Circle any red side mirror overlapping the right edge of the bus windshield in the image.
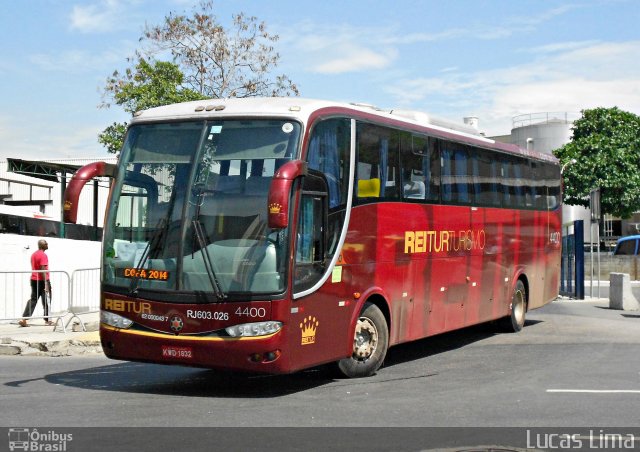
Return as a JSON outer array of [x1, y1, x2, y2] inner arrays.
[[267, 160, 307, 229]]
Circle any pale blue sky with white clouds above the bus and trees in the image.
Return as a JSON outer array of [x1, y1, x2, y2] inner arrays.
[[0, 0, 640, 159]]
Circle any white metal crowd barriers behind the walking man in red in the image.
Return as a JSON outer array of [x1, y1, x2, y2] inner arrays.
[[0, 268, 100, 331]]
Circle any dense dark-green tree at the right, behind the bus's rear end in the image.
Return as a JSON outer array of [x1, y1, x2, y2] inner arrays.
[[554, 107, 640, 218]]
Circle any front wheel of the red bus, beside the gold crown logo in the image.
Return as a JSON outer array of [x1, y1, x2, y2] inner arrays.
[[337, 302, 389, 378]]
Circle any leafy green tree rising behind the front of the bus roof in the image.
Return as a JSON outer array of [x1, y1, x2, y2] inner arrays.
[[98, 58, 204, 153]]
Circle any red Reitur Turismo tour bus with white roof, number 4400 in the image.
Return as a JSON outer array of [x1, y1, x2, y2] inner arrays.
[[65, 98, 561, 377]]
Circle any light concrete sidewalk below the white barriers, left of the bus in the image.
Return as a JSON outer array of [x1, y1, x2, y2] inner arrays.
[[0, 312, 102, 356]]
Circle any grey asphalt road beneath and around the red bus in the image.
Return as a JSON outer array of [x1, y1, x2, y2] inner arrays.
[[0, 302, 640, 450]]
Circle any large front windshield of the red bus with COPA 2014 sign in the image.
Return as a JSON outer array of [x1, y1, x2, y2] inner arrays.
[[103, 119, 300, 301]]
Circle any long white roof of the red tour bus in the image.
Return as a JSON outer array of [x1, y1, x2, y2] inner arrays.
[[131, 97, 557, 163]]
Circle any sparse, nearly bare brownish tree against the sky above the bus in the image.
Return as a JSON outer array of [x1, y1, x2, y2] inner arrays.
[[142, 1, 299, 99]]
